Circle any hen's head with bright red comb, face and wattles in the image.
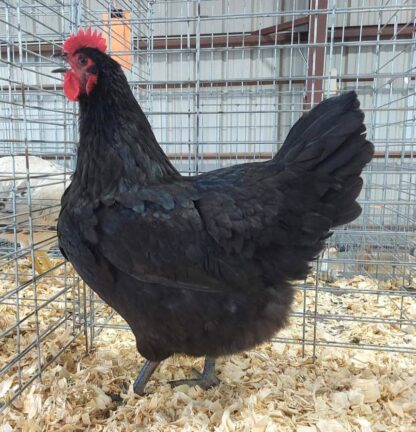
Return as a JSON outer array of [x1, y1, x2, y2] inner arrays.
[[52, 28, 107, 101]]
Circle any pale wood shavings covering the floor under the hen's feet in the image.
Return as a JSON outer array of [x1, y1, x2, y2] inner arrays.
[[0, 264, 416, 432]]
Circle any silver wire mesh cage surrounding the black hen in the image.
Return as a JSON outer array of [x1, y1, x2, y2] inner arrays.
[[0, 0, 416, 410]]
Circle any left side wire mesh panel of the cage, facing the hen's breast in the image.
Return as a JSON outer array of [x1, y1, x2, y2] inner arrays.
[[0, 0, 85, 410]]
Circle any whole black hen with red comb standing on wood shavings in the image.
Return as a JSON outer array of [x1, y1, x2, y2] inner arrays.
[[57, 30, 374, 393]]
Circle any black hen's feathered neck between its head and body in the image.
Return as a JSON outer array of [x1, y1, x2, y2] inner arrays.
[[73, 71, 179, 199]]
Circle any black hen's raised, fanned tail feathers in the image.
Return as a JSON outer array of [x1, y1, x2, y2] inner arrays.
[[275, 92, 374, 227]]
